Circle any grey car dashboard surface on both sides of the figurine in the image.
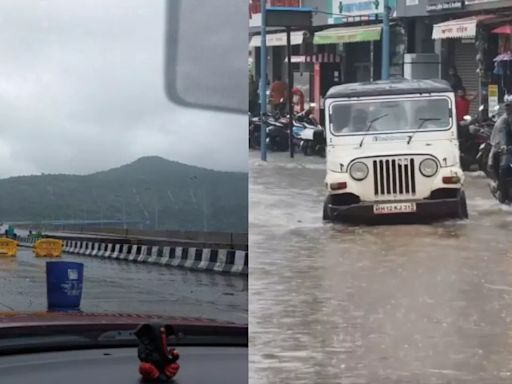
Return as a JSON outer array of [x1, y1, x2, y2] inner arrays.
[[0, 346, 248, 384]]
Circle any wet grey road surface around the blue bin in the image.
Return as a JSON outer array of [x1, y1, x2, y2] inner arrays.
[[0, 247, 248, 323]]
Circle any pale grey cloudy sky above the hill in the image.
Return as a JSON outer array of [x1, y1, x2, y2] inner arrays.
[[0, 0, 247, 177]]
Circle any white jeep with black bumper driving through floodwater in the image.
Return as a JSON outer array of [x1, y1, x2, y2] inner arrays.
[[323, 79, 468, 220]]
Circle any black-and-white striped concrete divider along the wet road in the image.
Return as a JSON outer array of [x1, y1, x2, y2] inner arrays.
[[19, 237, 249, 275]]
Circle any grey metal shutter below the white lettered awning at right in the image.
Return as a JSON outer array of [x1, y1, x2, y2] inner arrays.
[[455, 39, 480, 116]]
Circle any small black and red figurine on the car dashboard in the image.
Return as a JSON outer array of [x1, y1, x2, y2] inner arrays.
[[135, 323, 180, 383]]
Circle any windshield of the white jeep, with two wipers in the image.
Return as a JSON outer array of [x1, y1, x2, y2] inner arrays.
[[331, 98, 451, 135]]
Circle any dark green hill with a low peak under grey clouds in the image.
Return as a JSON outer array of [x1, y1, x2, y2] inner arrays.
[[0, 156, 248, 232]]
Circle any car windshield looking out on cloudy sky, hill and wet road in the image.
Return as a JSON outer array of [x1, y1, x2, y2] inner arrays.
[[0, 0, 248, 336]]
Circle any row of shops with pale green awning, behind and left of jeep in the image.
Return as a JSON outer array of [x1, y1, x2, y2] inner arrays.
[[249, 0, 405, 120]]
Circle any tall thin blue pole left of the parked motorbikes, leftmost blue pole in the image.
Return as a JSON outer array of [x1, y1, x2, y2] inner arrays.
[[260, 0, 267, 161]]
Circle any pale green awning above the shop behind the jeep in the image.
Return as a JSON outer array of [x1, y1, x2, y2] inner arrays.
[[313, 24, 382, 45]]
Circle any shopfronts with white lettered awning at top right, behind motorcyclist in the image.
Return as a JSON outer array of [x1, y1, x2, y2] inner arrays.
[[397, 0, 512, 113]]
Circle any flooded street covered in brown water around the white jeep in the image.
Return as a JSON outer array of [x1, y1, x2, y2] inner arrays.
[[249, 152, 512, 384]]
